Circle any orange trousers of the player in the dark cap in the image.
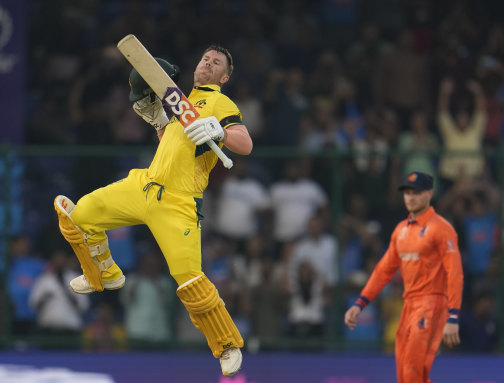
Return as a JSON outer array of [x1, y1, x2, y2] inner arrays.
[[403, 295, 444, 383]]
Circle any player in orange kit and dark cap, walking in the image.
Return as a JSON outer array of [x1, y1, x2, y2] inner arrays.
[[345, 172, 463, 383]]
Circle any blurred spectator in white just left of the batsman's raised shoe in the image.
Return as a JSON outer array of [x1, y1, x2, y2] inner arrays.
[[29, 250, 90, 336]]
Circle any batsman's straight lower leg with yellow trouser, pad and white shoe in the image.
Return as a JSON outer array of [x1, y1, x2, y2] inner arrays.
[[146, 192, 243, 375]]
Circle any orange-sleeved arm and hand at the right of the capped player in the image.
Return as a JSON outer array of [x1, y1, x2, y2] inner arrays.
[[438, 225, 464, 347]]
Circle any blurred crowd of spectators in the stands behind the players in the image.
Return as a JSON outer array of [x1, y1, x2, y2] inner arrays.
[[2, 0, 504, 352]]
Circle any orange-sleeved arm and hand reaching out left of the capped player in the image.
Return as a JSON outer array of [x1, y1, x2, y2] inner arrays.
[[345, 229, 401, 330]]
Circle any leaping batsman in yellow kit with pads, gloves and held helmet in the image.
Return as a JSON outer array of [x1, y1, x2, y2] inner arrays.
[[55, 45, 252, 376]]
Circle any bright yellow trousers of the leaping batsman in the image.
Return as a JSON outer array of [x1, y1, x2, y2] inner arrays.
[[72, 169, 202, 285]]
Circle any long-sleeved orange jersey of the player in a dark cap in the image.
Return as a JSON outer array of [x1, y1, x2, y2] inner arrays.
[[361, 207, 463, 311]]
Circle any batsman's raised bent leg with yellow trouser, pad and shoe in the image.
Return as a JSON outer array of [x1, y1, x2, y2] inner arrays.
[[55, 171, 145, 294]]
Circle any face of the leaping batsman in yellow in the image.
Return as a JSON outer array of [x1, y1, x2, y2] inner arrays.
[[194, 51, 229, 85]]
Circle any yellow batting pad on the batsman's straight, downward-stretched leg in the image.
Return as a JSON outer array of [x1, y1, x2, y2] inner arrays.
[[177, 275, 243, 358]]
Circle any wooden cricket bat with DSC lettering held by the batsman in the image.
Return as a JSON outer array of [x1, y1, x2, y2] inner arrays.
[[117, 34, 233, 169]]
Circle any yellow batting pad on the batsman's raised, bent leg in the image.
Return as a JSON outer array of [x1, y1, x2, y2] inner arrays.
[[54, 195, 104, 291]]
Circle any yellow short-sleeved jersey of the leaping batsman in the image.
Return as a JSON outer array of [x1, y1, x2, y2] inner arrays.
[[148, 85, 242, 197]]
